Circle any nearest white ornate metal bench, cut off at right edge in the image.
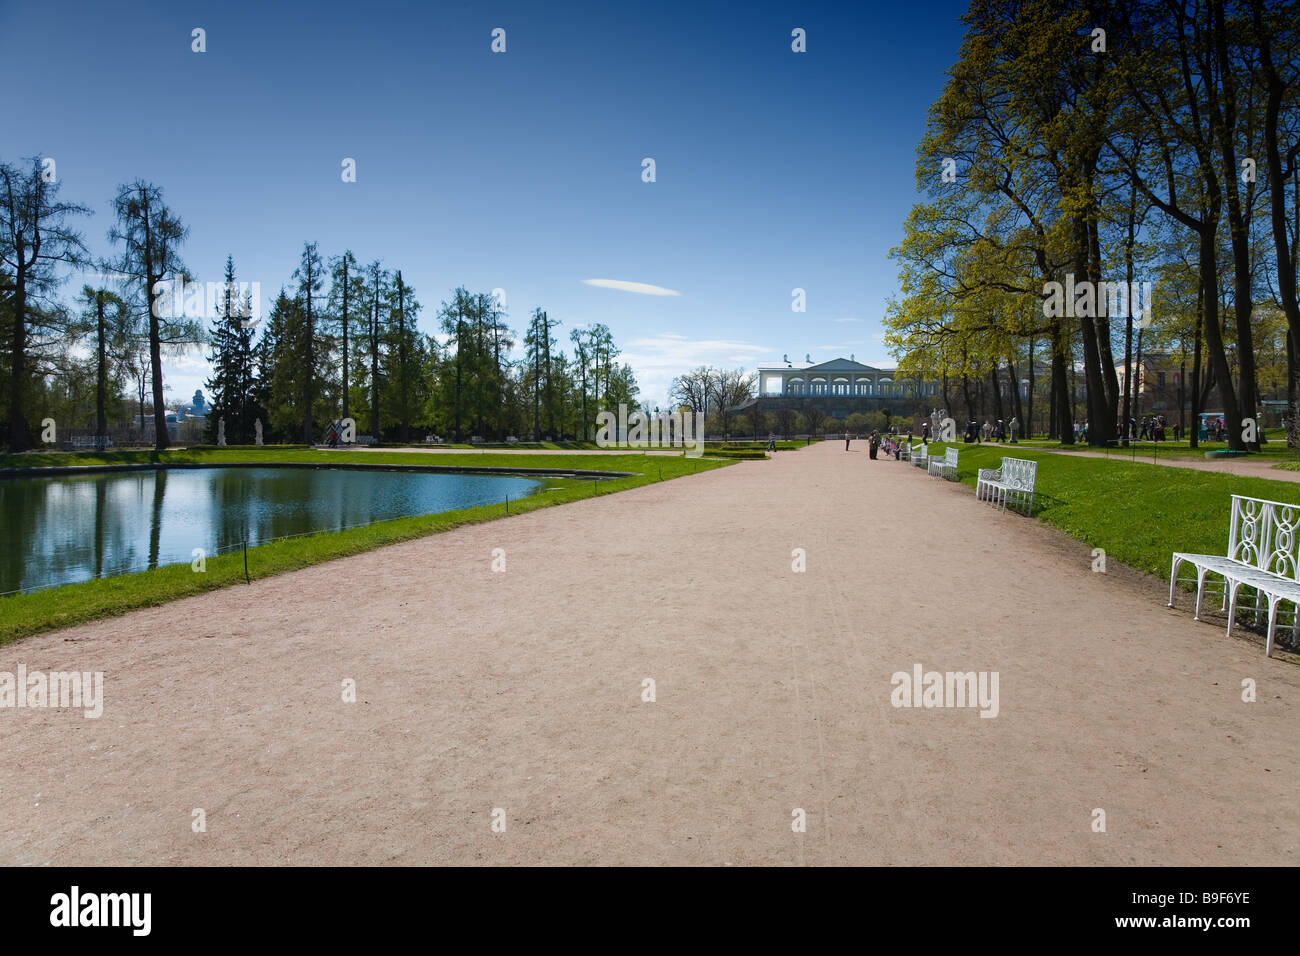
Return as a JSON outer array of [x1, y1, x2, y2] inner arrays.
[[1169, 494, 1300, 657]]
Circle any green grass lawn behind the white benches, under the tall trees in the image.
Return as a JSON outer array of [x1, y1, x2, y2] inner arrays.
[[930, 442, 1300, 580]]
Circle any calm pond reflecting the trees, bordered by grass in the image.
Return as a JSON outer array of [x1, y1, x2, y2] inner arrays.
[[0, 467, 545, 594]]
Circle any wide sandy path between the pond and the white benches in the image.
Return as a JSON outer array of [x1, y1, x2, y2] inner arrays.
[[0, 442, 1300, 865]]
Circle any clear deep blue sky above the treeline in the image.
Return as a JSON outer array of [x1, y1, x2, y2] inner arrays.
[[0, 0, 965, 403]]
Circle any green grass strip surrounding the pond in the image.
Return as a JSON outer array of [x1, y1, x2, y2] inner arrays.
[[0, 449, 731, 645]]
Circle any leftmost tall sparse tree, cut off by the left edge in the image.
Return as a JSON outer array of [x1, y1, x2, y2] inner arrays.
[[0, 156, 90, 451]]
